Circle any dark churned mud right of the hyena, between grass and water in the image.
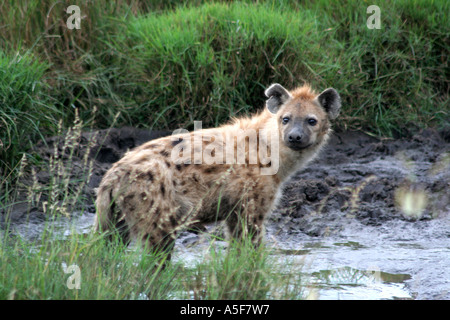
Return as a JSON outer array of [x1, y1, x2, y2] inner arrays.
[[272, 130, 450, 236]]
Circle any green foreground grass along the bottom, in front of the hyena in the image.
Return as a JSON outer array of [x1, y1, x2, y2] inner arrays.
[[0, 221, 303, 300]]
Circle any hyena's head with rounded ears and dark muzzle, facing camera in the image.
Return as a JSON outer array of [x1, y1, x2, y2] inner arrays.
[[265, 83, 341, 151]]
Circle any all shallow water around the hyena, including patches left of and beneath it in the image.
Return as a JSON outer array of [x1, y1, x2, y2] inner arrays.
[[7, 214, 450, 300]]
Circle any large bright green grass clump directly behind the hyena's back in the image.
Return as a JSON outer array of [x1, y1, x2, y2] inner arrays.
[[117, 3, 315, 128]]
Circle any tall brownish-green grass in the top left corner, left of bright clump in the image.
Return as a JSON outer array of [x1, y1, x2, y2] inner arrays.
[[0, 0, 198, 127]]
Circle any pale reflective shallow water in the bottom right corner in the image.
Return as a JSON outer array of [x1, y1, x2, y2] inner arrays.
[[268, 218, 450, 299]]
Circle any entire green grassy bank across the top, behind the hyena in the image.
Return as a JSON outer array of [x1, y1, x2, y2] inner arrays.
[[0, 0, 450, 180]]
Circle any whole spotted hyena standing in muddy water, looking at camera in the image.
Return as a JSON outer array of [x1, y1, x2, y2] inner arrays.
[[95, 84, 341, 260]]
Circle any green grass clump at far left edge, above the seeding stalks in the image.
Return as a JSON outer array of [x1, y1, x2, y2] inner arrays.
[[0, 51, 61, 179]]
